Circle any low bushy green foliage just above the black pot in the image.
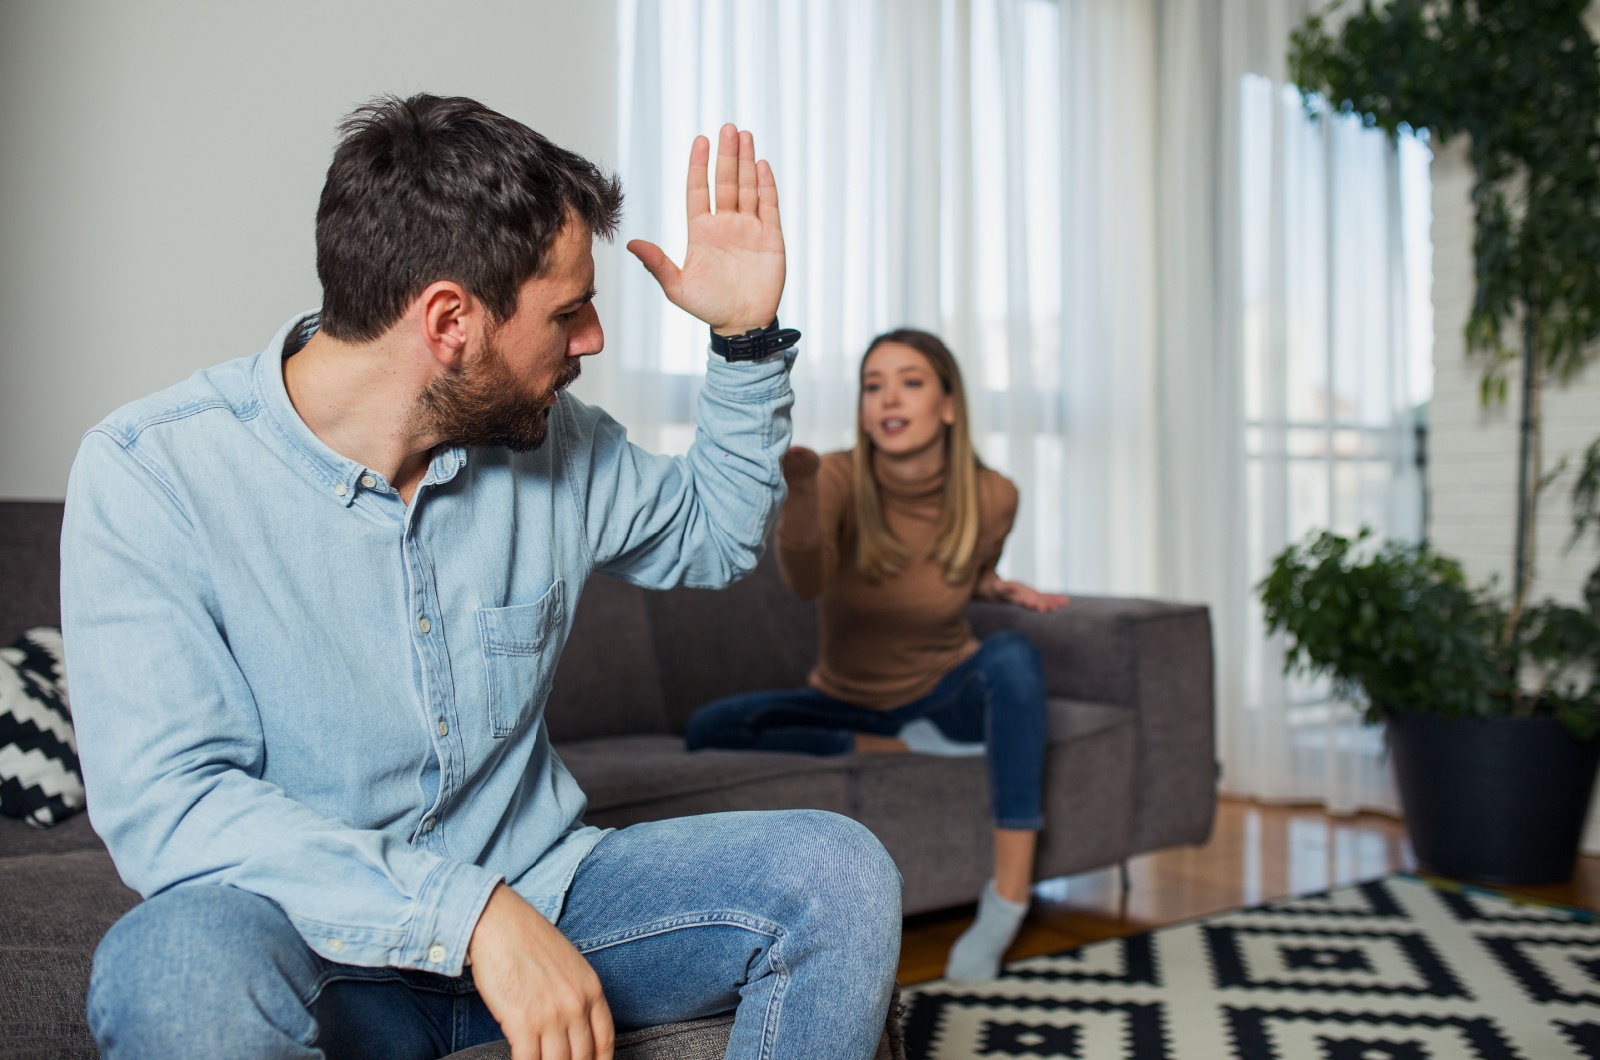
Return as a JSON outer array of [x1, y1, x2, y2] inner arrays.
[[1256, 530, 1600, 738]]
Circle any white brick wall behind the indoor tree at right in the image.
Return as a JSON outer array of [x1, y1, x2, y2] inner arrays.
[[1429, 143, 1600, 853]]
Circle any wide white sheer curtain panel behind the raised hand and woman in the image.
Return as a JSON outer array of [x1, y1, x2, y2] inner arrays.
[[606, 0, 1155, 592]]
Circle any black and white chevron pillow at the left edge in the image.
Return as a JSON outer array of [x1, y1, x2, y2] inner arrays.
[[0, 628, 83, 828]]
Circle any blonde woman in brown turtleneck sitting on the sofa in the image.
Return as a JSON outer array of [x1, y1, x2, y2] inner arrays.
[[686, 328, 1067, 982]]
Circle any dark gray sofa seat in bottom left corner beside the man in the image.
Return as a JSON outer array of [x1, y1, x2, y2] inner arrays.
[[0, 849, 139, 1057]]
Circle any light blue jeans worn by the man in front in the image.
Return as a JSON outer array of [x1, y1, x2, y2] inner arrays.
[[88, 810, 901, 1060]]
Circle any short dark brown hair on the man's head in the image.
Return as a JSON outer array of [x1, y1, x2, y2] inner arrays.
[[317, 94, 622, 341]]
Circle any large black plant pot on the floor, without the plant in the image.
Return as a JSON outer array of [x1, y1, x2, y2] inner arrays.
[[1387, 711, 1600, 884]]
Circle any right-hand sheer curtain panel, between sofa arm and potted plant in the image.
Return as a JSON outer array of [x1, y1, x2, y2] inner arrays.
[[1158, 0, 1432, 812]]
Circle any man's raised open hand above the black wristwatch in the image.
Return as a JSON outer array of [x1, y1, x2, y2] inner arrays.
[[627, 125, 784, 335]]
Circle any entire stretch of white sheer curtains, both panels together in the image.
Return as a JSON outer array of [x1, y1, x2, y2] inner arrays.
[[614, 0, 1429, 810]]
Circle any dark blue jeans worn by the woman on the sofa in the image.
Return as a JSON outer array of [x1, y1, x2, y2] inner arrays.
[[685, 631, 1048, 831]]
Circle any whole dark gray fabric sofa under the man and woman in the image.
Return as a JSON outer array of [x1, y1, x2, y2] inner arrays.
[[0, 501, 1214, 1060]]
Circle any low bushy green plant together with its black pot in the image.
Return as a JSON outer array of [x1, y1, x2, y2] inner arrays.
[[1258, 532, 1600, 884]]
